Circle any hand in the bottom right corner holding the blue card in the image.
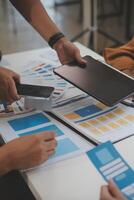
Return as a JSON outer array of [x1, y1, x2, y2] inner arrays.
[[100, 180, 125, 200]]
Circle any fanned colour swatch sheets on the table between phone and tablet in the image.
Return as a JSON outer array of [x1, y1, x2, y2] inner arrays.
[[21, 60, 68, 100]]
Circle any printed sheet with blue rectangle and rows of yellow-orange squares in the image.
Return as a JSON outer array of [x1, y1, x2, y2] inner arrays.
[[53, 94, 134, 143]]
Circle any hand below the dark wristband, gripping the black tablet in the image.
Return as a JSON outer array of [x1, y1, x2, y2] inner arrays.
[[53, 38, 86, 64]]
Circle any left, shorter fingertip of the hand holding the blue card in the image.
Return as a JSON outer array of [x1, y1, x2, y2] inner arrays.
[[100, 185, 112, 200]]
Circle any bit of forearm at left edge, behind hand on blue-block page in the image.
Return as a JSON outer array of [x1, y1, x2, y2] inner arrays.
[[0, 145, 12, 176]]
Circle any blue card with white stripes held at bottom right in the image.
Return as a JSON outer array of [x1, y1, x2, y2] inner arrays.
[[87, 142, 134, 199]]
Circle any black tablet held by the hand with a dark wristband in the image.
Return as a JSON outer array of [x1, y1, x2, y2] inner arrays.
[[54, 56, 134, 106]]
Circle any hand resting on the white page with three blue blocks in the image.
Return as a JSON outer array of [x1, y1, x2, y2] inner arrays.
[[2, 131, 56, 171]]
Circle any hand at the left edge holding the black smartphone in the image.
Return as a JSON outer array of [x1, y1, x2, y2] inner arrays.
[[0, 67, 20, 103]]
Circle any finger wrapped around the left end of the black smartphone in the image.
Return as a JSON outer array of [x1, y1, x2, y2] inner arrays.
[[9, 78, 20, 101]]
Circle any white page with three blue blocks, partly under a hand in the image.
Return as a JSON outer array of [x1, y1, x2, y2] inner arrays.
[[0, 111, 92, 166]]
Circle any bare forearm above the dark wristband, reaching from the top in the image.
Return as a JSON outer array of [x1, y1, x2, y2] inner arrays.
[[10, 0, 59, 41]]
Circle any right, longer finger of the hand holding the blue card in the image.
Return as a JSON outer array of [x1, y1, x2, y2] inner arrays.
[[108, 179, 123, 199]]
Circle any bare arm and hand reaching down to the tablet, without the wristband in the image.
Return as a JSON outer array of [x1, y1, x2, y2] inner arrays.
[[10, 0, 85, 64]]
